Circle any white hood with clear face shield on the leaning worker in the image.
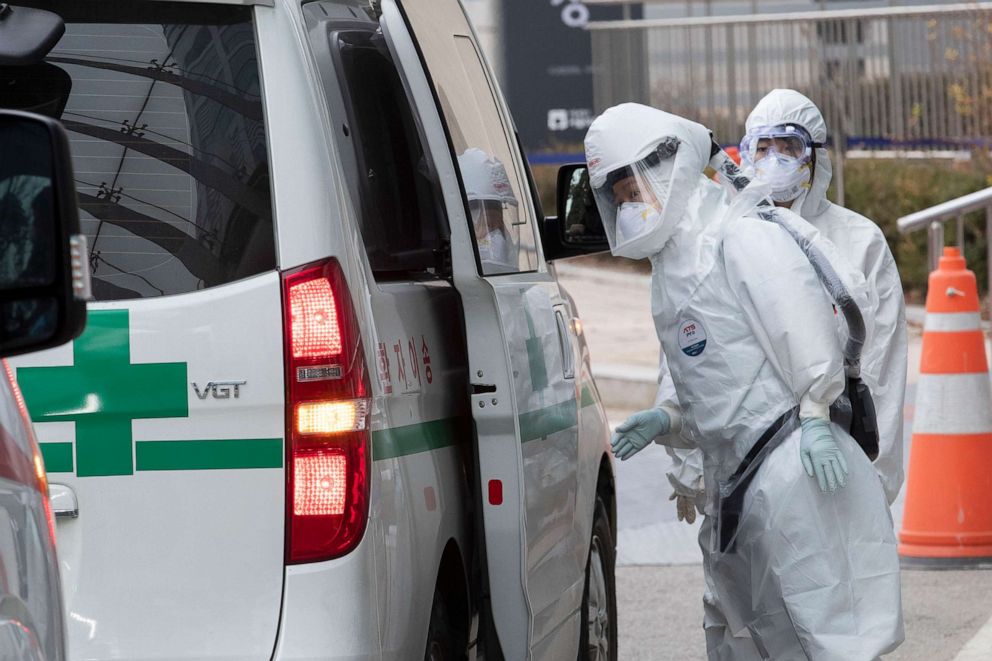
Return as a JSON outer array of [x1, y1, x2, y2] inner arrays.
[[585, 103, 712, 259]]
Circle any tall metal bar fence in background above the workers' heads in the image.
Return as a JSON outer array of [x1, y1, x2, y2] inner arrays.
[[588, 2, 992, 151]]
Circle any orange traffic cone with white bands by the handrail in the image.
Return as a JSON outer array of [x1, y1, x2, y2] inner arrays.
[[899, 248, 992, 568]]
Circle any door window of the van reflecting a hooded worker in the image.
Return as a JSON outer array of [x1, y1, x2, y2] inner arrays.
[[396, 2, 539, 275]]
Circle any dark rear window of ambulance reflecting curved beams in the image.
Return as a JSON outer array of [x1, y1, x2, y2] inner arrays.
[[0, 0, 276, 300]]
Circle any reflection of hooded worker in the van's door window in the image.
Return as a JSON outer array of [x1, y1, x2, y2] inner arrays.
[[458, 147, 519, 275]]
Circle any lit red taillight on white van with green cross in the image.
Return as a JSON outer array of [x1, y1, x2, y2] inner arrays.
[[283, 259, 371, 563]]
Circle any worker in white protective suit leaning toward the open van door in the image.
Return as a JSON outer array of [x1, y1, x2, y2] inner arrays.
[[586, 104, 903, 660]]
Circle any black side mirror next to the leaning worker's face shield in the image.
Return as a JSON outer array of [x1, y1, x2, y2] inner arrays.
[[542, 163, 610, 260]]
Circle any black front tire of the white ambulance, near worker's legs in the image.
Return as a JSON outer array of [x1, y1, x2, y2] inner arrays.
[[579, 497, 617, 661]]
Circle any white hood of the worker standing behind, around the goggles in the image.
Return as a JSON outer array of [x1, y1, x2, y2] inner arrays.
[[744, 89, 833, 218]]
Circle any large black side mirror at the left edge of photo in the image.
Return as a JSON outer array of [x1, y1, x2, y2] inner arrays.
[[0, 110, 90, 357]]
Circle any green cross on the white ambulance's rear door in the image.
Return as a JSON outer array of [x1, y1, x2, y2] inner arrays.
[[17, 310, 189, 477]]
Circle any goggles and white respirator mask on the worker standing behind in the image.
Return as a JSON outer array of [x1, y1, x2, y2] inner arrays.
[[740, 124, 823, 202]]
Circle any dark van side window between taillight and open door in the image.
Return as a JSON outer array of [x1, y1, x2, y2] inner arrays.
[[306, 3, 448, 280]]
